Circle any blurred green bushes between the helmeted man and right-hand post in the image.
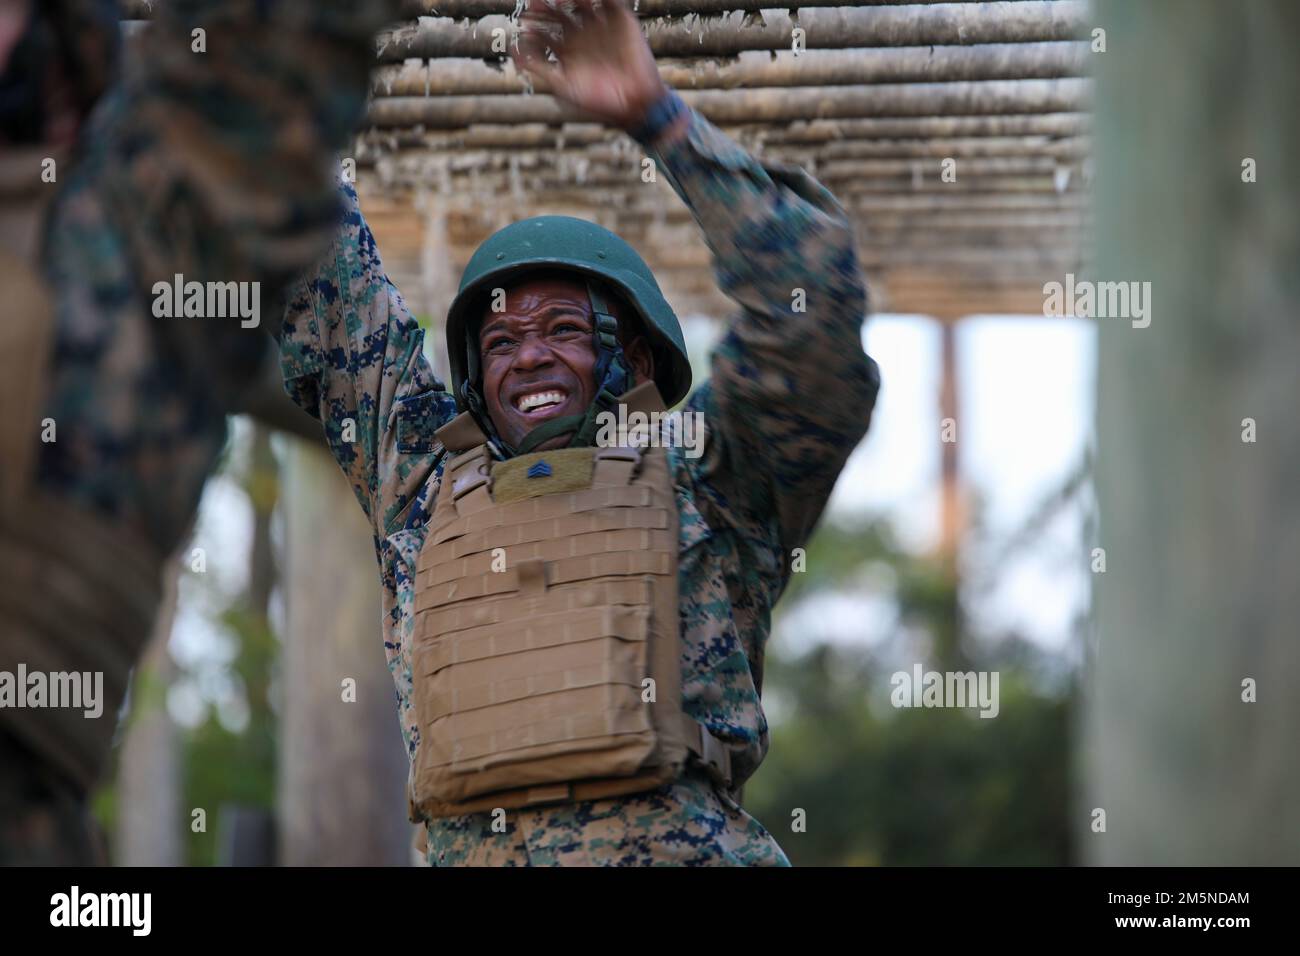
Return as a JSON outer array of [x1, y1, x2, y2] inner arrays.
[[744, 523, 1075, 866]]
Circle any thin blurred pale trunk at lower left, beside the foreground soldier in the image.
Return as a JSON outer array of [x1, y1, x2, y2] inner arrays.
[[113, 561, 185, 866]]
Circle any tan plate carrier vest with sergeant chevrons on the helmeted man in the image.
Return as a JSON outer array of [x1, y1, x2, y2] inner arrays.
[[411, 382, 731, 819]]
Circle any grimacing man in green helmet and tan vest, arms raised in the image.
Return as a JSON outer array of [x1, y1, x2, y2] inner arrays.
[[281, 0, 879, 866]]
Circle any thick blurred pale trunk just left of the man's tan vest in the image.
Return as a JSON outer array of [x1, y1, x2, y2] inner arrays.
[[277, 441, 411, 866]]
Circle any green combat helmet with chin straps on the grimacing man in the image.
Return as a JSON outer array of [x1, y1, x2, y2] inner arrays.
[[447, 216, 690, 457]]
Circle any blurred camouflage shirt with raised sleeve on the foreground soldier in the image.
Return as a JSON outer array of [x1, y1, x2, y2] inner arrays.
[[38, 0, 397, 553]]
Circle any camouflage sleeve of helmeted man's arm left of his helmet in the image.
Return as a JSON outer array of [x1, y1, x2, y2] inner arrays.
[[280, 185, 456, 538]]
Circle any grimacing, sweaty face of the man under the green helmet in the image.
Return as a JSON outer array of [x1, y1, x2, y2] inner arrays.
[[478, 273, 654, 450]]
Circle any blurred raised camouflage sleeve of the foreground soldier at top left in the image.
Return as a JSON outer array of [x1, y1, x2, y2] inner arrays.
[[99, 0, 398, 345]]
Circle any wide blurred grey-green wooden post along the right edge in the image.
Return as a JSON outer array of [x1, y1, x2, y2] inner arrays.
[[1079, 0, 1300, 865]]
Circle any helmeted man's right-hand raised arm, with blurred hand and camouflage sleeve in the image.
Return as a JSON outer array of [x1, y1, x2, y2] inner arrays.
[[515, 0, 879, 574]]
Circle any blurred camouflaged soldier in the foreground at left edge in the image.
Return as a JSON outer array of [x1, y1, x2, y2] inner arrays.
[[0, 0, 395, 864]]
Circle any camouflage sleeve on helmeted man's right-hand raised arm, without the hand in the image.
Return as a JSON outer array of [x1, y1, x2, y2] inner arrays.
[[650, 112, 880, 580]]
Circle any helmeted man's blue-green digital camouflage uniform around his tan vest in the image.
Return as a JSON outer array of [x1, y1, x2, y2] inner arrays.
[[282, 104, 879, 865]]
